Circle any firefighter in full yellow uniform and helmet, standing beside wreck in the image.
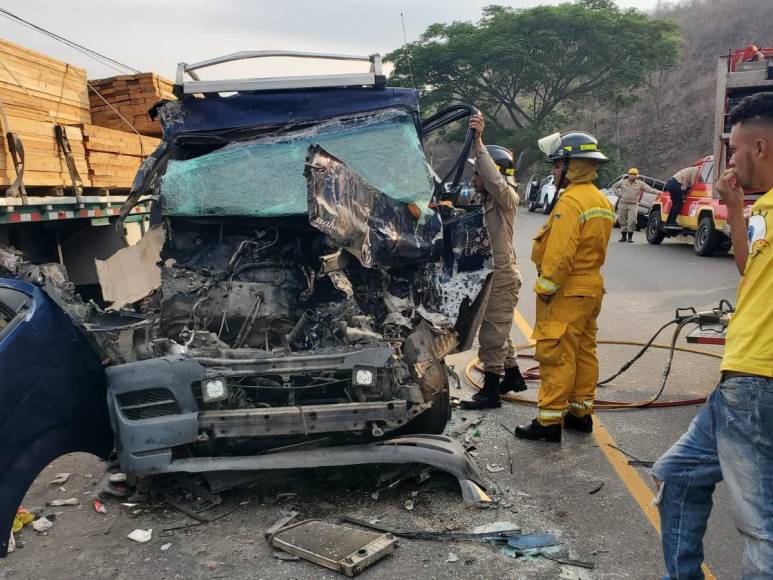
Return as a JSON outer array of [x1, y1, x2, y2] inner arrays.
[[515, 131, 615, 442]]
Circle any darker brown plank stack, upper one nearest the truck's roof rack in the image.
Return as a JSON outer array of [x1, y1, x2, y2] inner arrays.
[[90, 73, 175, 137]]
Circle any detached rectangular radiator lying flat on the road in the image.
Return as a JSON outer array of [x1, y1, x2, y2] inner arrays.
[[269, 520, 395, 577]]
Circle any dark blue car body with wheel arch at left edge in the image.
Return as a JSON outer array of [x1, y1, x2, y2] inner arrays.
[[0, 279, 113, 556]]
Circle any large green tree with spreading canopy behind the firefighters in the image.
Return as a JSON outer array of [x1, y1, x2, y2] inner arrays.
[[386, 0, 681, 165]]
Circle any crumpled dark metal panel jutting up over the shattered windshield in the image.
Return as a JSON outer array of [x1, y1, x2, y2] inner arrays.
[[306, 145, 443, 268]]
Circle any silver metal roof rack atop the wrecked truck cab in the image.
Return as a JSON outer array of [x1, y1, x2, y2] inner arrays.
[[175, 50, 386, 96]]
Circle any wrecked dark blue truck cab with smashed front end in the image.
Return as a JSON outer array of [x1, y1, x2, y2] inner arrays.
[[106, 55, 491, 478]]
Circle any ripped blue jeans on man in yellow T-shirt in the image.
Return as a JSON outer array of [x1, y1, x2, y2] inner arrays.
[[652, 377, 773, 580]]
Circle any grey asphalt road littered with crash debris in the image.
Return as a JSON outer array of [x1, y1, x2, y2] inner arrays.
[[6, 211, 741, 579]]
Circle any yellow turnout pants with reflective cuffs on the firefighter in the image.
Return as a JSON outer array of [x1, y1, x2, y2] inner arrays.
[[532, 274, 604, 425]]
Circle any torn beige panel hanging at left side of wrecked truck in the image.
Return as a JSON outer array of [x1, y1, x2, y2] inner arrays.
[[94, 225, 166, 310]]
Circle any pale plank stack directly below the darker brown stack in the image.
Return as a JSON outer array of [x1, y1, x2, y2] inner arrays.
[[78, 124, 160, 188]]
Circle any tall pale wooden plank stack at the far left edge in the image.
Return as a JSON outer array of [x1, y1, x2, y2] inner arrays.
[[0, 39, 91, 187]]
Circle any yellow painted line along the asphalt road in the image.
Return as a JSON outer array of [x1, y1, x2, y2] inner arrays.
[[513, 310, 716, 580]]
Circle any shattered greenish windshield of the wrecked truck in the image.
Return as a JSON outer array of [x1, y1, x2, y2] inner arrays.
[[161, 109, 433, 217]]
